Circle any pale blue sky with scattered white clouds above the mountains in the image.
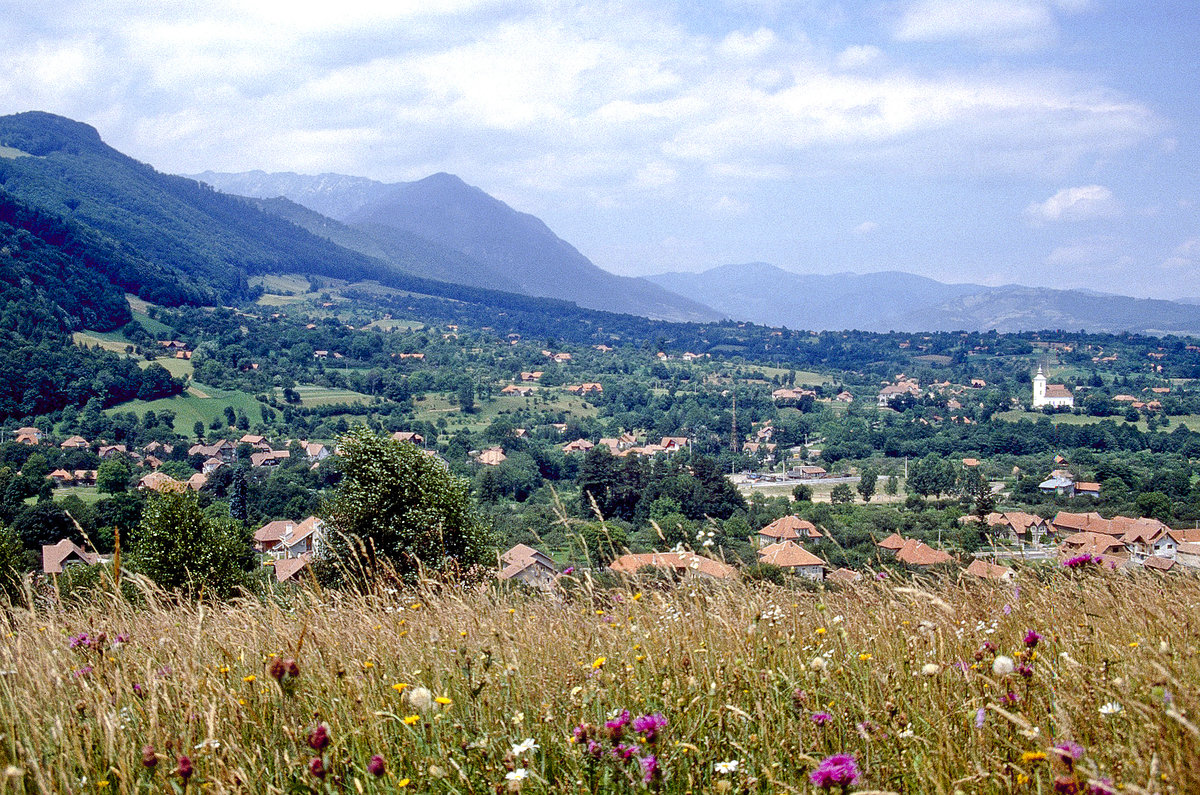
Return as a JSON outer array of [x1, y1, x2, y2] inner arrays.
[[0, 0, 1200, 298]]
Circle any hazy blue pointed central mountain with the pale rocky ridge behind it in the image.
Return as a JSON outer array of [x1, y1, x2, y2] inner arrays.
[[192, 172, 721, 322]]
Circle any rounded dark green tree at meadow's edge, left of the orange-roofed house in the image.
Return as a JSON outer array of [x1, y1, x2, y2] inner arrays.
[[130, 492, 254, 597]]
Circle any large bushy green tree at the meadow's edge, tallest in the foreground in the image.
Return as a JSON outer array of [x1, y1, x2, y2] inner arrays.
[[325, 425, 493, 586]]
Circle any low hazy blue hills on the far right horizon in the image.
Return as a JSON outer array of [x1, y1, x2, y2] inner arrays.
[[648, 263, 1200, 334]]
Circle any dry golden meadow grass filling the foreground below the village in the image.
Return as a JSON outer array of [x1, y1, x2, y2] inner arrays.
[[0, 570, 1200, 794]]
